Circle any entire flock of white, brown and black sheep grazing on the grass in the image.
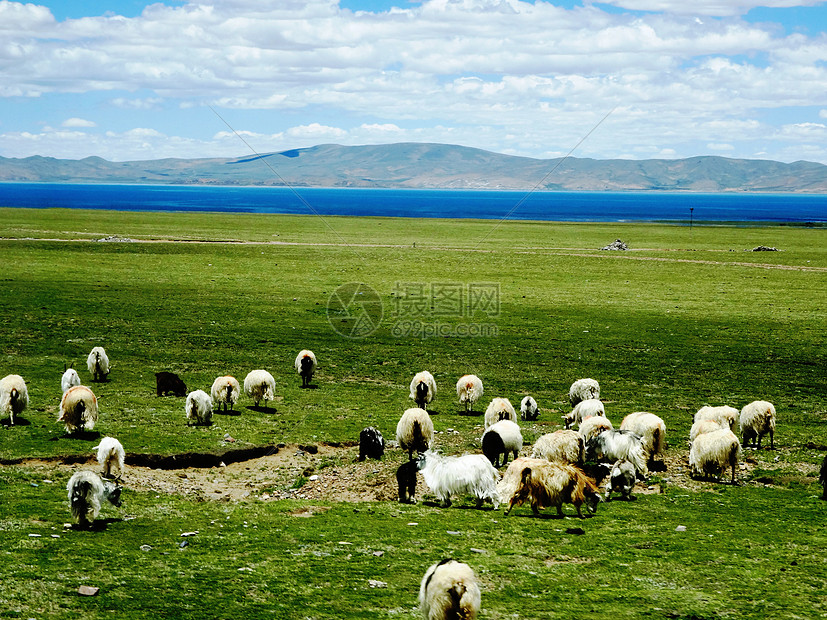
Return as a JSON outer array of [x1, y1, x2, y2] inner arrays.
[[0, 346, 827, 619]]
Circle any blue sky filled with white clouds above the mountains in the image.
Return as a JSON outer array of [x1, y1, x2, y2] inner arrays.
[[0, 0, 827, 164]]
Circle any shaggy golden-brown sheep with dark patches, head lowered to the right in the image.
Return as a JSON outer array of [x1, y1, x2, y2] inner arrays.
[[497, 459, 600, 519]]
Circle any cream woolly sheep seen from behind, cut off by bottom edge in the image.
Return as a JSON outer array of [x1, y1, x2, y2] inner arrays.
[[419, 558, 480, 620]]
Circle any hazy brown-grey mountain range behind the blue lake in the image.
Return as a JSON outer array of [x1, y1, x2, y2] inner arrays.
[[0, 143, 827, 193]]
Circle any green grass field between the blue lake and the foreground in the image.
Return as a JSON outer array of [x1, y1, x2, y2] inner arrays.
[[0, 209, 827, 620]]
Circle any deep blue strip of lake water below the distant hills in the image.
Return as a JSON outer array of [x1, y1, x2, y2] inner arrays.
[[0, 183, 827, 223]]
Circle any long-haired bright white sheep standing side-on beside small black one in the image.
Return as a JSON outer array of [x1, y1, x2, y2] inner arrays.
[[419, 450, 500, 510]]
